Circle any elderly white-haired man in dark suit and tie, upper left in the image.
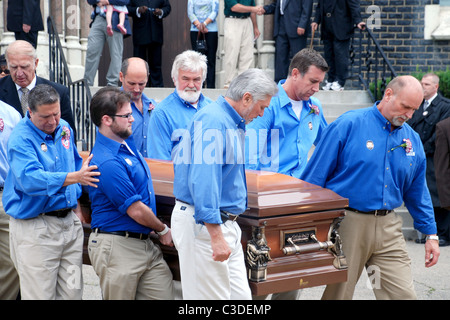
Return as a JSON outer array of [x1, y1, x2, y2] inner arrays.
[[0, 40, 76, 136]]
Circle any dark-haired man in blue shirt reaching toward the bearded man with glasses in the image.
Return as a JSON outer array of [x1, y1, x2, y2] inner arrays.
[[3, 85, 99, 300]]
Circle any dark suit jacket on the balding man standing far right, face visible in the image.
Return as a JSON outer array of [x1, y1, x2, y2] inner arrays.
[[408, 94, 450, 207]]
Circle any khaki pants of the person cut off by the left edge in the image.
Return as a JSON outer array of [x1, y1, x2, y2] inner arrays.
[[0, 191, 19, 300]]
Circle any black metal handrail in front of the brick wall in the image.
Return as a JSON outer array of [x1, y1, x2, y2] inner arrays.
[[350, 28, 397, 101]]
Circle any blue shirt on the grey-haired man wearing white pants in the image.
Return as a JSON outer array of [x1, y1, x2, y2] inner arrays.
[[173, 97, 247, 224]]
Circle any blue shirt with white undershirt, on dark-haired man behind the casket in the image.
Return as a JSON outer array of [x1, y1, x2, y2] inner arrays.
[[245, 80, 327, 178]]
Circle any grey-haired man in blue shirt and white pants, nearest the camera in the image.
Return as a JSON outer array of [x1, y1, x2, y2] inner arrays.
[[171, 69, 277, 299]]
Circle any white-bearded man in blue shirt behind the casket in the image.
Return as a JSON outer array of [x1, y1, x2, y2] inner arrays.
[[147, 50, 212, 160]]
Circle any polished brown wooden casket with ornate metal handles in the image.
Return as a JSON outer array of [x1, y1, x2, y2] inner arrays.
[[81, 152, 348, 296]]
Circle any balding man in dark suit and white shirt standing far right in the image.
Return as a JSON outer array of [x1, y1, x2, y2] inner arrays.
[[407, 73, 450, 247]]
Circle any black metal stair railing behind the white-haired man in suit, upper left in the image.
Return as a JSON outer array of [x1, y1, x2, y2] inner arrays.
[[47, 16, 96, 150]]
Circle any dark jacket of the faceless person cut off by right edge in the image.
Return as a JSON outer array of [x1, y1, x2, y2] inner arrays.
[[434, 118, 450, 209]]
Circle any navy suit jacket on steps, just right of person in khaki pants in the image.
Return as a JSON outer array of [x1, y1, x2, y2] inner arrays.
[[264, 0, 313, 38]]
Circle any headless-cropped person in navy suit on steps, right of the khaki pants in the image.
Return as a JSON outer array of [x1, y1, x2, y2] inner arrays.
[[264, 0, 313, 82]]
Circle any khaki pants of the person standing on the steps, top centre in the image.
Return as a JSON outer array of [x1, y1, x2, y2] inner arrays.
[[223, 18, 254, 87]]
